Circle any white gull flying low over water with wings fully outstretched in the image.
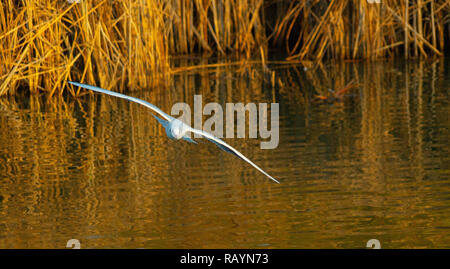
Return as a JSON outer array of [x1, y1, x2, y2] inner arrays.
[[68, 81, 280, 183]]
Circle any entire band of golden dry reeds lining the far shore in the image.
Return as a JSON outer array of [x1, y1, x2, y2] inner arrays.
[[0, 0, 450, 96]]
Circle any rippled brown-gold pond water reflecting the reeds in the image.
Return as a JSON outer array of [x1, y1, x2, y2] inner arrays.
[[0, 59, 450, 248]]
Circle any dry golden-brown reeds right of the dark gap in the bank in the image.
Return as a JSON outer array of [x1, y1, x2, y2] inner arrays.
[[274, 0, 450, 60]]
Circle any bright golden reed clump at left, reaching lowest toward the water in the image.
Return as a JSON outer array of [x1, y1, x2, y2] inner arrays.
[[0, 0, 171, 95]]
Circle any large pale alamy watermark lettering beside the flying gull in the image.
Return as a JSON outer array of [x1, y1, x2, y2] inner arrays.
[[170, 95, 280, 149]]
